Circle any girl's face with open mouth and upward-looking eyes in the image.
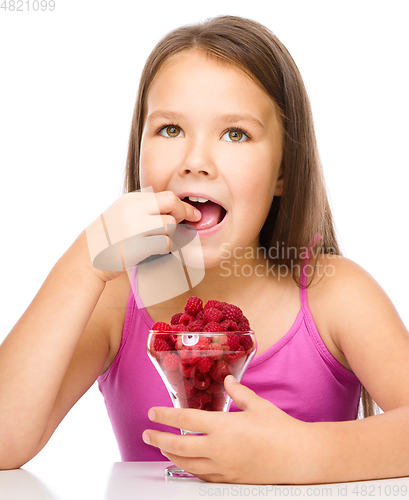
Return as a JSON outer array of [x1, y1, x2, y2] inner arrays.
[[140, 50, 283, 268]]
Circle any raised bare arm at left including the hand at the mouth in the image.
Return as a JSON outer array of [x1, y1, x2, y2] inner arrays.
[[0, 192, 200, 469]]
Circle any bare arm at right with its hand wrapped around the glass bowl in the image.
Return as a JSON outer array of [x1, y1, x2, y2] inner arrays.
[[144, 259, 409, 484]]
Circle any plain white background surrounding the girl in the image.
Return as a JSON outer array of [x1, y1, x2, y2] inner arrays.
[[0, 0, 409, 496]]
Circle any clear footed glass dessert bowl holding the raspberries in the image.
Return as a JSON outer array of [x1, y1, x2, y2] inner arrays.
[[147, 330, 257, 477]]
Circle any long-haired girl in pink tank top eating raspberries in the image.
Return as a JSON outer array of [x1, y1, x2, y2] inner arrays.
[[0, 16, 409, 484]]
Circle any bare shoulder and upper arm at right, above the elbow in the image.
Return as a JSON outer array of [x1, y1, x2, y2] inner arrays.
[[309, 255, 409, 411]]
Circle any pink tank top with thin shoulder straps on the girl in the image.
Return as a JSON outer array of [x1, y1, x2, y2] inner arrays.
[[98, 250, 361, 461]]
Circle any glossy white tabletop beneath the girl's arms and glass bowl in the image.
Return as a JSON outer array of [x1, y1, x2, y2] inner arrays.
[[0, 462, 409, 500]]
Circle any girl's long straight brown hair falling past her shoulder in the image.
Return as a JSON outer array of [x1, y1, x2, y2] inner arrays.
[[124, 16, 373, 416]]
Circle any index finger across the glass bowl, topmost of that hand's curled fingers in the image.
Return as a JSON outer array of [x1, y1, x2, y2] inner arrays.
[[148, 406, 217, 434]]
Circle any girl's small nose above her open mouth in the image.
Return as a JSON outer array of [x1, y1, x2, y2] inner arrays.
[[179, 140, 217, 178]]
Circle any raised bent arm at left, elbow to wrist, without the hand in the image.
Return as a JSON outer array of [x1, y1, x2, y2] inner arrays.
[[0, 233, 109, 469]]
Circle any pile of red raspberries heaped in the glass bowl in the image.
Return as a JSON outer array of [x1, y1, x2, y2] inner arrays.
[[148, 297, 255, 411]]
